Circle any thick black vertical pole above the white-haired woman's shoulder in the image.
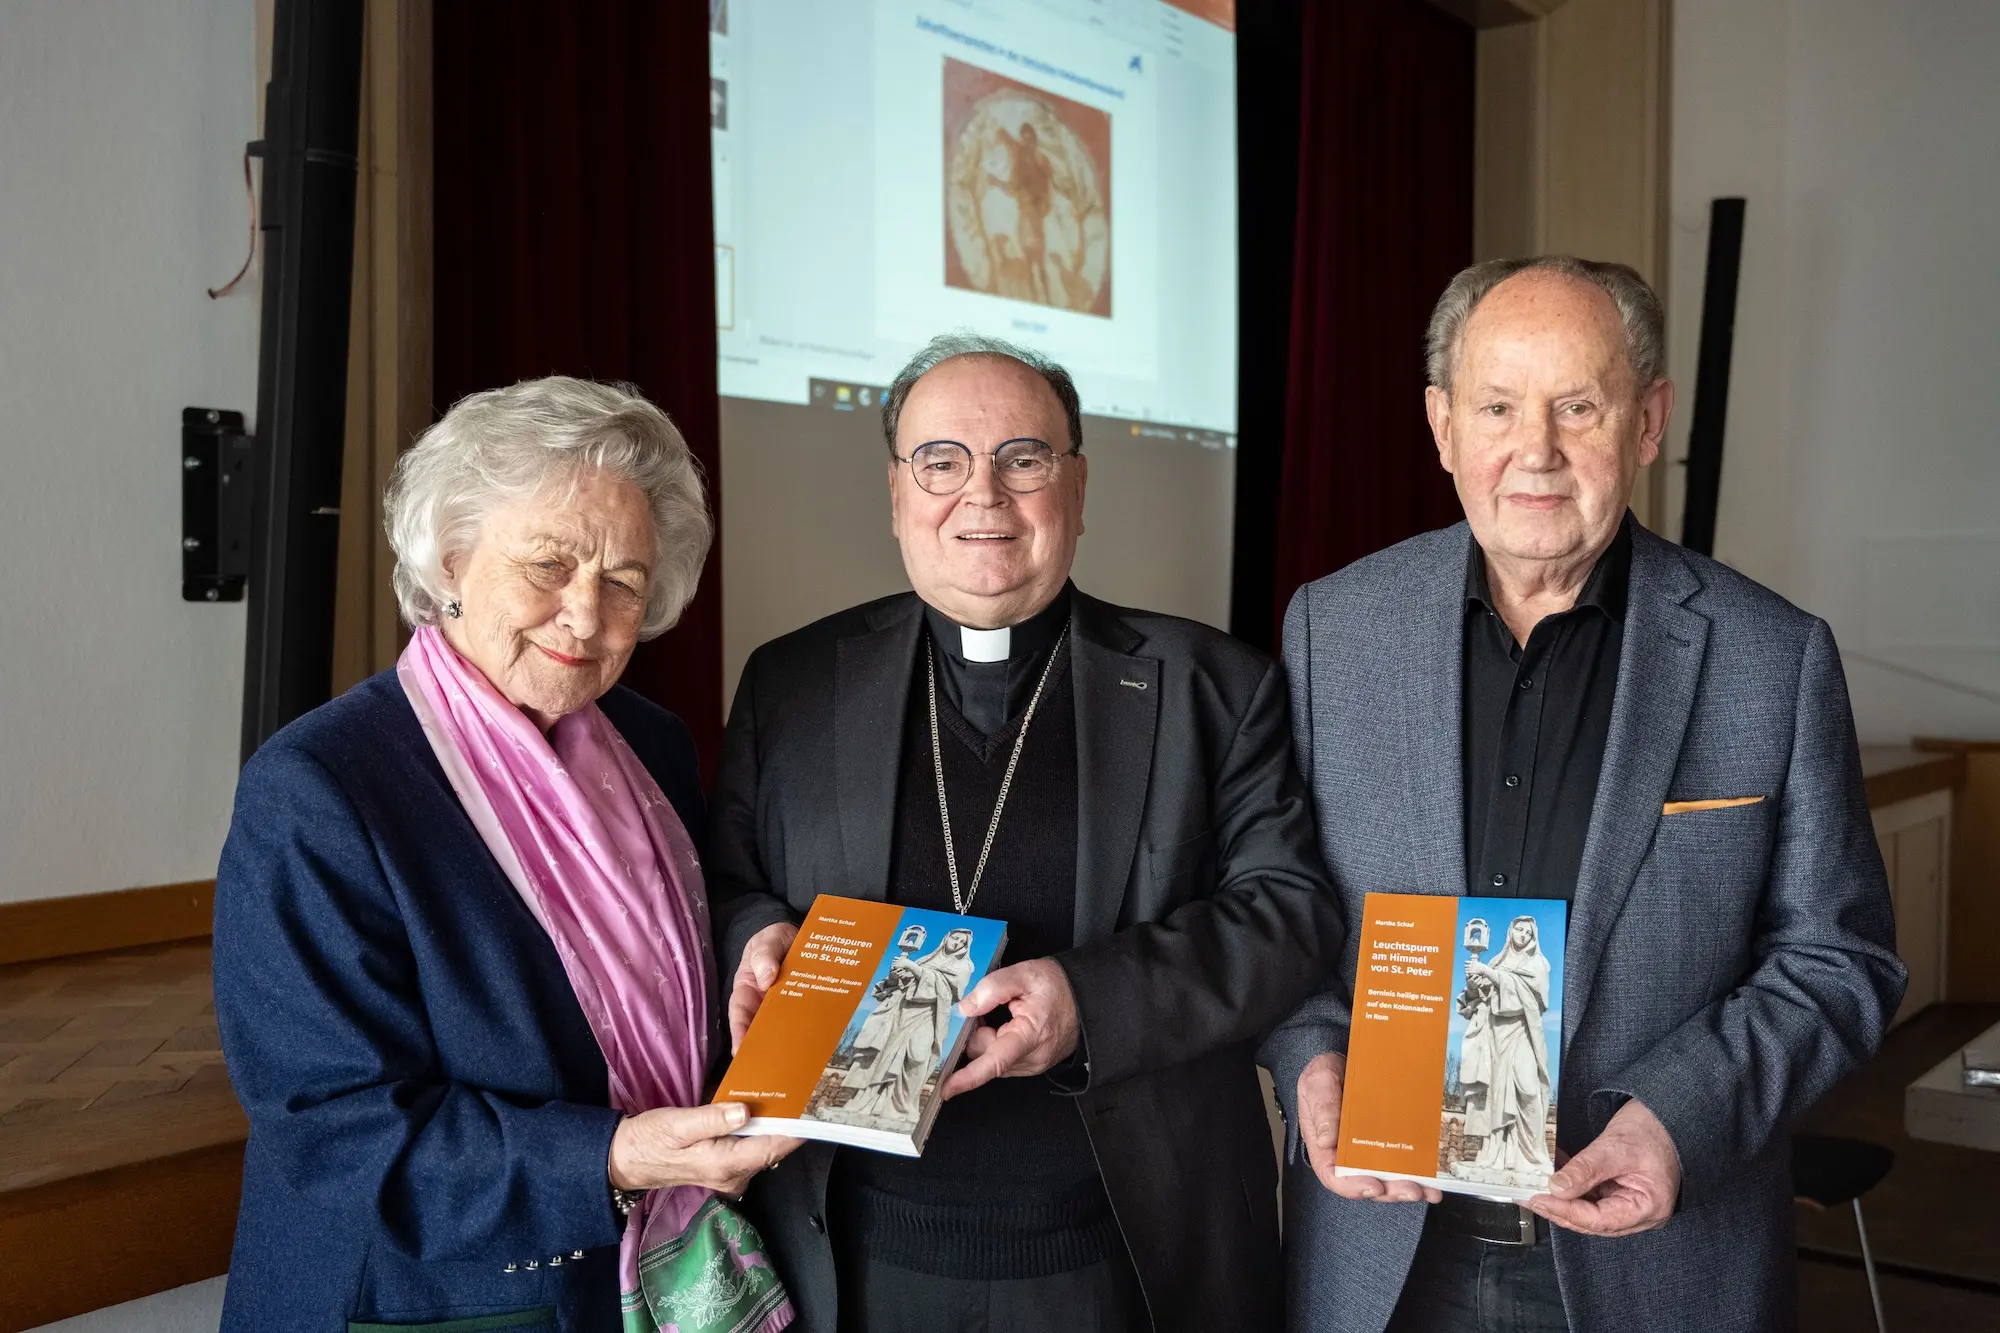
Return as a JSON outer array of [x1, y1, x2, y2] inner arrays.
[[242, 0, 362, 759]]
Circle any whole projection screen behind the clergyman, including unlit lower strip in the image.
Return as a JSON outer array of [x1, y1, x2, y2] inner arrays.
[[710, 0, 1236, 693]]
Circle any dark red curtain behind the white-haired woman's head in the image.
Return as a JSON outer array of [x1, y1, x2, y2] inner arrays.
[[434, 0, 722, 777]]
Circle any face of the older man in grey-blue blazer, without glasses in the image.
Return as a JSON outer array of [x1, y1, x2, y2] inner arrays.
[[1424, 270, 1674, 562]]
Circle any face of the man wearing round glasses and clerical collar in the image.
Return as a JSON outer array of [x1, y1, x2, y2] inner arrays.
[[888, 356, 1088, 628]]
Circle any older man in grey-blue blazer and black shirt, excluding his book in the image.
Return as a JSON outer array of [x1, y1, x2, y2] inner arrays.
[[1260, 256, 1904, 1333]]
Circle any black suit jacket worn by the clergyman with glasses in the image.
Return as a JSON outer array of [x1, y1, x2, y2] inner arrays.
[[704, 592, 1340, 1333]]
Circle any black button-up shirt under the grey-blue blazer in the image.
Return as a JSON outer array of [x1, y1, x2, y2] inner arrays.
[[1462, 514, 1632, 899]]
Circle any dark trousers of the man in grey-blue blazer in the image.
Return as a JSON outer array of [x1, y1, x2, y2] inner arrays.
[[1386, 1217, 1570, 1333]]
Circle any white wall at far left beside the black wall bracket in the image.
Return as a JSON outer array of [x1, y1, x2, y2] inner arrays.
[[0, 0, 258, 901]]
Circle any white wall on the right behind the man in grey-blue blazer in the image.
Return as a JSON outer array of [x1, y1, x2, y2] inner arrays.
[[1668, 0, 2000, 741]]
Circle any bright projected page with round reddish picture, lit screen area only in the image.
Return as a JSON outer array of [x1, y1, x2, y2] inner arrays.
[[710, 0, 1236, 442]]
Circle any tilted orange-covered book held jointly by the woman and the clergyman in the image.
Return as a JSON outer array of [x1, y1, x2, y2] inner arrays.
[[716, 893, 1006, 1157]]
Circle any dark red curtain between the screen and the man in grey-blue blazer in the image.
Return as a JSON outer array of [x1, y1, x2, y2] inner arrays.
[[1272, 0, 1474, 620]]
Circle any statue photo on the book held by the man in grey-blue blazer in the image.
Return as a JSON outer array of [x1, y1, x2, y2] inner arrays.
[[1438, 899, 1568, 1191]]
